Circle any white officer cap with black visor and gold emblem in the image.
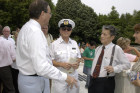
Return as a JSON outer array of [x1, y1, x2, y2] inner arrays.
[[58, 19, 75, 29]]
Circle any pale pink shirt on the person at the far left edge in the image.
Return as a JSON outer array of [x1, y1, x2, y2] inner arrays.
[[0, 37, 16, 67]]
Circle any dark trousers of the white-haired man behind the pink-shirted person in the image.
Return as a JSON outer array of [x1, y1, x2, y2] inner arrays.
[[11, 68, 19, 93]]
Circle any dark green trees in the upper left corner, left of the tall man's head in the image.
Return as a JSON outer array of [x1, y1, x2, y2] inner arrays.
[[0, 0, 30, 30]]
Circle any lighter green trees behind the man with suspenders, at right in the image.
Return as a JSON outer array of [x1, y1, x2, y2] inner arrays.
[[98, 6, 140, 43]]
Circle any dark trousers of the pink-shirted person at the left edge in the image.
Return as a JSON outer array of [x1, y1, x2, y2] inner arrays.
[[0, 66, 15, 93]]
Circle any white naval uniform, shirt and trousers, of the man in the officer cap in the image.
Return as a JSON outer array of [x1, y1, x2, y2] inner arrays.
[[50, 36, 81, 93]]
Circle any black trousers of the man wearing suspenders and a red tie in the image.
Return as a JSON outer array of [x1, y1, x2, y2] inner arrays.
[[88, 77, 115, 93]]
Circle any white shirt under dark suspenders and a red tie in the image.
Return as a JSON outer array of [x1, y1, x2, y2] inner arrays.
[[91, 42, 131, 77]]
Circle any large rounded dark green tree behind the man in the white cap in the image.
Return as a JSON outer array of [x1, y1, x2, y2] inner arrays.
[[56, 0, 97, 42]]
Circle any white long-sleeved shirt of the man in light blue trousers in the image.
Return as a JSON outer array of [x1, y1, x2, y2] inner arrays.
[[16, 19, 67, 80]]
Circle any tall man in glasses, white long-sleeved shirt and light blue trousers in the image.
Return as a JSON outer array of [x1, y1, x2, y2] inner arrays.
[[16, 0, 77, 93]]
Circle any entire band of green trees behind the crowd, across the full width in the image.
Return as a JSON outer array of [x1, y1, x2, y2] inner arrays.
[[0, 0, 140, 43]]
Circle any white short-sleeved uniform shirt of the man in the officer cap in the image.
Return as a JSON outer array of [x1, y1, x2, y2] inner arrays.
[[50, 36, 81, 72]]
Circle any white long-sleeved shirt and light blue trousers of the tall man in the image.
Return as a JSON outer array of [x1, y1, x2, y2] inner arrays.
[[16, 19, 67, 93]]
